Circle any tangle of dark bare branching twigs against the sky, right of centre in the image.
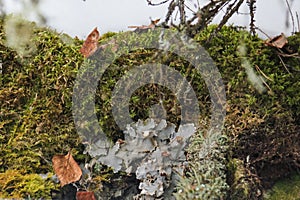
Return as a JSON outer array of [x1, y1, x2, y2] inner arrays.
[[146, 0, 257, 36]]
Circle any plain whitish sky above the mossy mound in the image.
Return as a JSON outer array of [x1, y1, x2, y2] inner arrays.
[[2, 0, 300, 39]]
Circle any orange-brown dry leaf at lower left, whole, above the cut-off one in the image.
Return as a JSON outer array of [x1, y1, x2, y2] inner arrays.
[[52, 152, 82, 187]]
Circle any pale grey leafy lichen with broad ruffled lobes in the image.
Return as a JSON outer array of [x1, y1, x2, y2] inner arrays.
[[86, 119, 196, 199]]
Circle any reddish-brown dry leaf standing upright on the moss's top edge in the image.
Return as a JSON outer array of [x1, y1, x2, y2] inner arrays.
[[80, 27, 100, 58]]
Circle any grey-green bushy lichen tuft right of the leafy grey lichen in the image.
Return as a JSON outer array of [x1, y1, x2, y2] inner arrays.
[[175, 129, 229, 199]]
